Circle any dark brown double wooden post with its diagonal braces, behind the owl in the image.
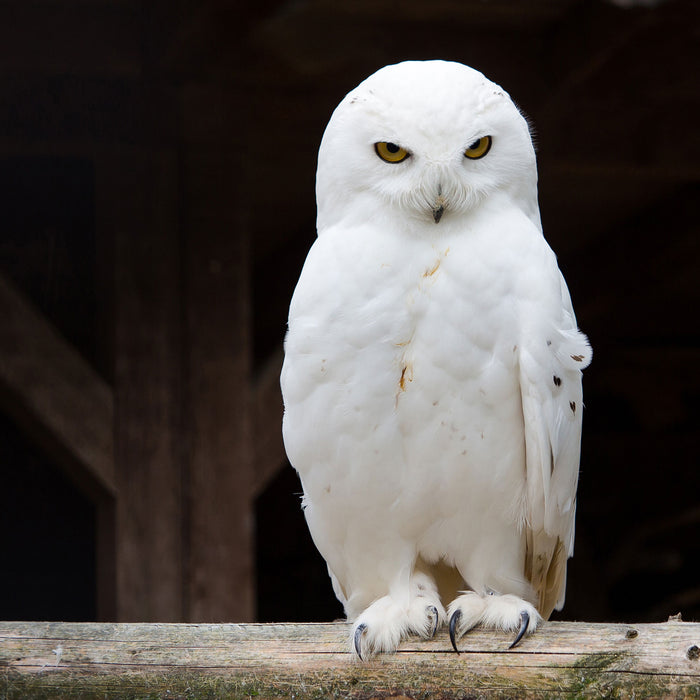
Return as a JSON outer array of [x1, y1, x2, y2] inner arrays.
[[0, 120, 284, 621]]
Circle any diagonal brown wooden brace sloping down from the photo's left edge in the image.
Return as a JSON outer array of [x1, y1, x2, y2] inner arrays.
[[0, 275, 117, 497]]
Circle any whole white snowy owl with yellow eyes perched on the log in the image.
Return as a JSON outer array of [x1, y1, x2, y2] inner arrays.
[[281, 61, 591, 658]]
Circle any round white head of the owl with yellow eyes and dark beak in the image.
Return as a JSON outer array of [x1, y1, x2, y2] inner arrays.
[[316, 61, 539, 233]]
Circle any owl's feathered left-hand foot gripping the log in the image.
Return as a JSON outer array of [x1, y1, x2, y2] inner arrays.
[[352, 594, 446, 660]]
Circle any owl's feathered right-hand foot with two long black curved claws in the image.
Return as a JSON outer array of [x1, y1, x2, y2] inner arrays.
[[448, 591, 542, 653]]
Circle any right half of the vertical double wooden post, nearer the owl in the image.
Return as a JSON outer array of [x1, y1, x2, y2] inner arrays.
[[182, 142, 255, 622]]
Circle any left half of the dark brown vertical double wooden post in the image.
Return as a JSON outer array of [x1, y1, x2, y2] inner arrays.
[[103, 148, 185, 622]]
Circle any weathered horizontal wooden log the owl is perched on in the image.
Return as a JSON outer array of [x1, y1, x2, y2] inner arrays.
[[0, 621, 700, 700]]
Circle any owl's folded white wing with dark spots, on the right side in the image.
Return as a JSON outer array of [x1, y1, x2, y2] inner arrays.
[[519, 275, 592, 619]]
